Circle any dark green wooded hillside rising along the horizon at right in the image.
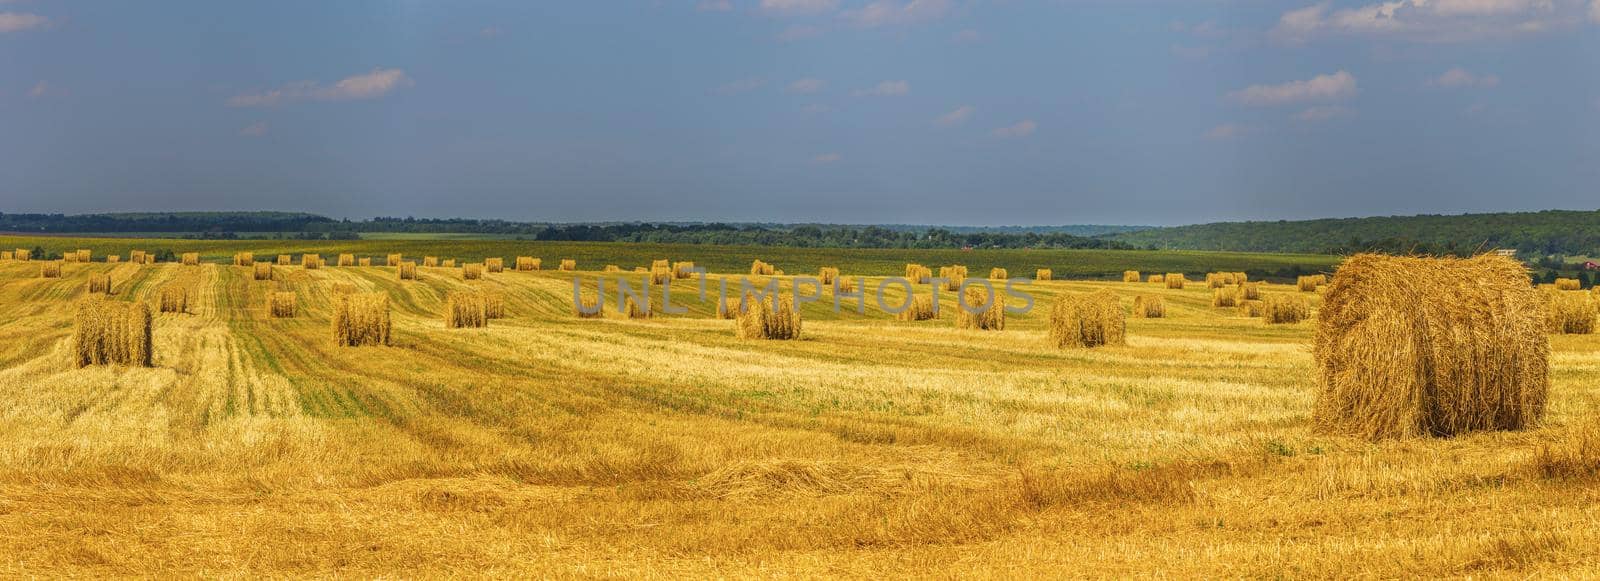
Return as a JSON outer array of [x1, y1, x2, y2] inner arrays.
[[1102, 210, 1600, 254]]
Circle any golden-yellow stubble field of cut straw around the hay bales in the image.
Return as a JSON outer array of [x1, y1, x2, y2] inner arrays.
[[0, 256, 1600, 578]]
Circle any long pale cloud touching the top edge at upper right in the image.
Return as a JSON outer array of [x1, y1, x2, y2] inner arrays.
[[1270, 0, 1581, 43]]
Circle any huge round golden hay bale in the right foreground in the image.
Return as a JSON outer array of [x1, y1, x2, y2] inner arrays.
[[1312, 254, 1550, 440]]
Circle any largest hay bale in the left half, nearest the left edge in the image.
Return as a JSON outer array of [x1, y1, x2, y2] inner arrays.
[[72, 298, 154, 368]]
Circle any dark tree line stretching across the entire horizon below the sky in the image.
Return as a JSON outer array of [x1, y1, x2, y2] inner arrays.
[[9, 210, 1600, 261]]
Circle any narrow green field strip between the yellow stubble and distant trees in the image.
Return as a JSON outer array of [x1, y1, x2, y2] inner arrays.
[[0, 235, 1339, 278]]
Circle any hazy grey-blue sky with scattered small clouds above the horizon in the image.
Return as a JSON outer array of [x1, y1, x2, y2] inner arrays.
[[0, 0, 1600, 226]]
